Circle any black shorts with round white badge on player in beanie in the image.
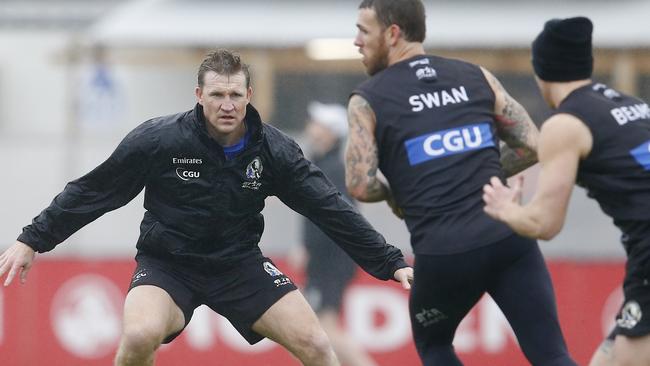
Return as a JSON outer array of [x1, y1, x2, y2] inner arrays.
[[609, 239, 650, 339]]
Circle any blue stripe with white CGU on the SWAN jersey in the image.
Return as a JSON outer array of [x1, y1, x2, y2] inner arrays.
[[404, 122, 494, 166]]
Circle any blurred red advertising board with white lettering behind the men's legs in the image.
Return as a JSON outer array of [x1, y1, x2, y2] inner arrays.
[[0, 258, 624, 366]]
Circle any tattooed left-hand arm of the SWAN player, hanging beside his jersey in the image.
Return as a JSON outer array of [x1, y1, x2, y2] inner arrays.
[[345, 95, 390, 202]]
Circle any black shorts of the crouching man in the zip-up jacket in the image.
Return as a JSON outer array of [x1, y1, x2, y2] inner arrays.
[[129, 254, 296, 344]]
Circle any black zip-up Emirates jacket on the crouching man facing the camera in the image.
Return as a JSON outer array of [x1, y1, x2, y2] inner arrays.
[[18, 104, 407, 280]]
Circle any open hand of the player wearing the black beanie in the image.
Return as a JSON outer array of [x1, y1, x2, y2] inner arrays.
[[483, 175, 524, 222]]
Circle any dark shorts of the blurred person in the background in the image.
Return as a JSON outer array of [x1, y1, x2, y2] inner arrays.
[[303, 243, 357, 313]]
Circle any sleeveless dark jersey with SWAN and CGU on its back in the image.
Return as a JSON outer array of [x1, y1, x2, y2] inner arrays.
[[354, 55, 512, 254]]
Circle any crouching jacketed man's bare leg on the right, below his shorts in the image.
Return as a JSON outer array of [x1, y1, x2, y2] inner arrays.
[[253, 290, 339, 366]]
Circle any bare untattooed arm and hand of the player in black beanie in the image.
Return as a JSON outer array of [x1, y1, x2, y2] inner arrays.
[[483, 114, 592, 240]]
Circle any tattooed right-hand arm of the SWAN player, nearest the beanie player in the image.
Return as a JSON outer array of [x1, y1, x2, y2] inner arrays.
[[481, 68, 539, 177]]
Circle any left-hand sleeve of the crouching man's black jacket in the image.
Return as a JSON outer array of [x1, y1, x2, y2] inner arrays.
[[18, 129, 150, 253]]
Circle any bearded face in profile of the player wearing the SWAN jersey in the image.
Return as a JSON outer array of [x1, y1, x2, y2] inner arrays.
[[354, 8, 388, 75]]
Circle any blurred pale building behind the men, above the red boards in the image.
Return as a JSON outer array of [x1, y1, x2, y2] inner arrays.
[[0, 0, 650, 258]]
